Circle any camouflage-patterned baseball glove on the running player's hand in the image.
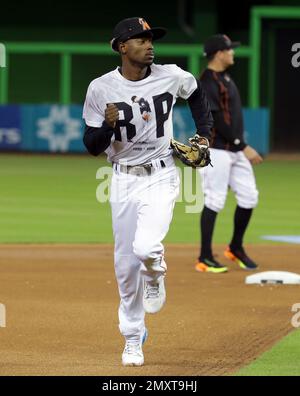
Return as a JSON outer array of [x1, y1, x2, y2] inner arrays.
[[171, 134, 211, 168]]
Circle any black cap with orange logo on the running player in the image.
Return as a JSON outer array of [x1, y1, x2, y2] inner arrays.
[[110, 17, 167, 52]]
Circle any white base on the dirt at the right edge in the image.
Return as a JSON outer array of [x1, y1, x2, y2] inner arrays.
[[245, 271, 300, 285]]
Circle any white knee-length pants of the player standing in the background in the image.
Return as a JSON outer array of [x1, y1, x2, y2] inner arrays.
[[200, 149, 258, 212]]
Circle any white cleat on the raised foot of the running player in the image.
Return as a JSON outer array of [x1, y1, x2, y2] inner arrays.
[[143, 276, 166, 314]]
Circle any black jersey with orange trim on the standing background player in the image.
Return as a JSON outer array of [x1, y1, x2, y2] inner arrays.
[[200, 69, 246, 152]]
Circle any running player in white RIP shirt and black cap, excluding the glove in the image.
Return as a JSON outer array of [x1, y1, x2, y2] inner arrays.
[[83, 18, 213, 366]]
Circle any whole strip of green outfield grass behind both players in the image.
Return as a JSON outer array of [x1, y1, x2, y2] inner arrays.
[[0, 154, 300, 243]]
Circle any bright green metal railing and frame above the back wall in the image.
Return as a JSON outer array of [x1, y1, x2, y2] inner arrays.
[[0, 6, 300, 108]]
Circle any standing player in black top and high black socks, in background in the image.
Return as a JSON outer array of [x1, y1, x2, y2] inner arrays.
[[196, 34, 262, 273]]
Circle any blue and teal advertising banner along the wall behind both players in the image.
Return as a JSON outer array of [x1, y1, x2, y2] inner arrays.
[[0, 105, 269, 154]]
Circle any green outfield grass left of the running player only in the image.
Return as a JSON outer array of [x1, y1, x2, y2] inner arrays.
[[0, 155, 112, 243]]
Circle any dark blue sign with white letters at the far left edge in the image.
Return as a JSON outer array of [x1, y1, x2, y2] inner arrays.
[[0, 106, 22, 151]]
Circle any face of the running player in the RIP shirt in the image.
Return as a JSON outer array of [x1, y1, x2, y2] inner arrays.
[[124, 36, 154, 66]]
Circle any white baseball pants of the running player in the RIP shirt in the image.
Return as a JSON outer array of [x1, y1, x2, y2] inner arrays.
[[110, 159, 179, 337]]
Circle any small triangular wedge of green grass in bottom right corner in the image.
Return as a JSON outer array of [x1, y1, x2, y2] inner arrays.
[[236, 330, 300, 376]]
